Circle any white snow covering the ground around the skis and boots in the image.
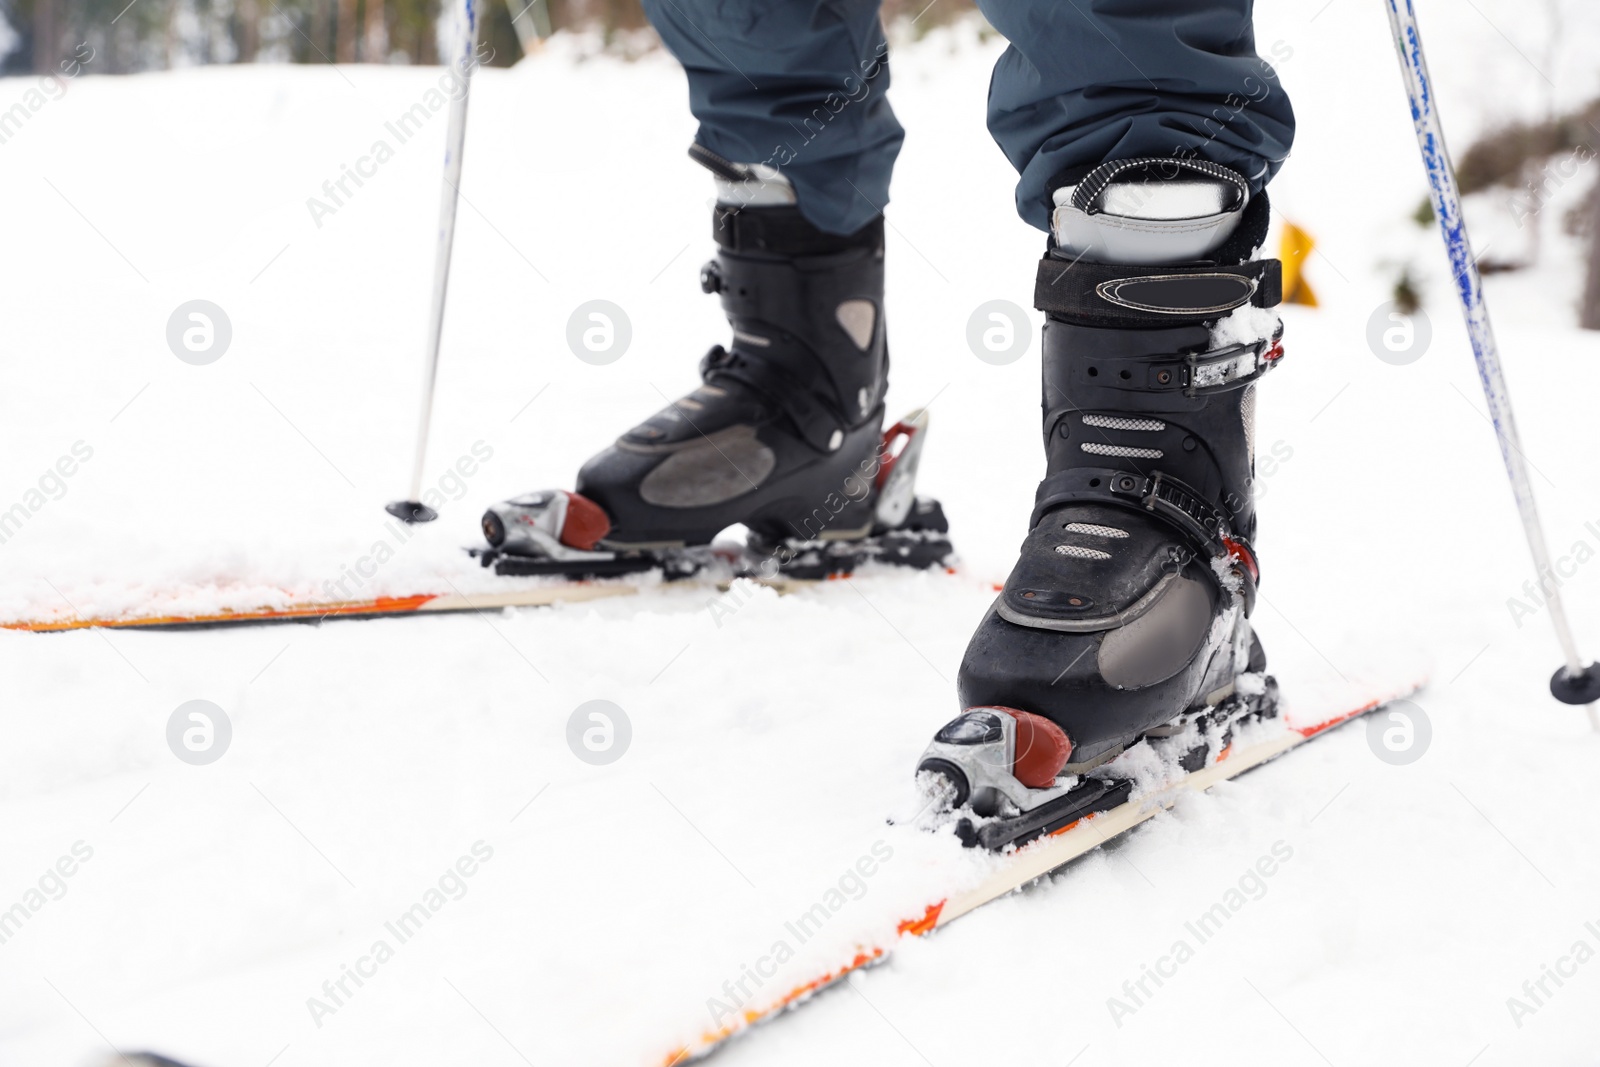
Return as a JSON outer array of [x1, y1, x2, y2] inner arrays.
[[0, 0, 1600, 1067]]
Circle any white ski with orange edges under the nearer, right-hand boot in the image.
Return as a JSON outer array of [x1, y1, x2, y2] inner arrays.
[[661, 678, 1426, 1067]]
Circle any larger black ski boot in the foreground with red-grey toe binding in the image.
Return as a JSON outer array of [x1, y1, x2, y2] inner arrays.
[[918, 160, 1283, 848]]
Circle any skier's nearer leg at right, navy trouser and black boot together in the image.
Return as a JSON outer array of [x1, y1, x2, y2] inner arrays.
[[928, 0, 1291, 825]]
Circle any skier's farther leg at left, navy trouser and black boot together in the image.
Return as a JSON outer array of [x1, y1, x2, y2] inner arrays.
[[485, 0, 947, 576]]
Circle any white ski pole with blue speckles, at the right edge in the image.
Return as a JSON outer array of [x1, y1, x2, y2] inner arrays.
[[1386, 0, 1600, 729]]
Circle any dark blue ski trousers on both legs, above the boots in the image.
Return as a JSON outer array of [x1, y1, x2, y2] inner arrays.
[[643, 0, 1294, 234]]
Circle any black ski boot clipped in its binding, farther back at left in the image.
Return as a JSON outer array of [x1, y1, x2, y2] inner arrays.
[[483, 146, 950, 579]]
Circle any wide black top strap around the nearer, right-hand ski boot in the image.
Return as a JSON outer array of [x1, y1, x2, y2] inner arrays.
[[1034, 256, 1283, 326]]
